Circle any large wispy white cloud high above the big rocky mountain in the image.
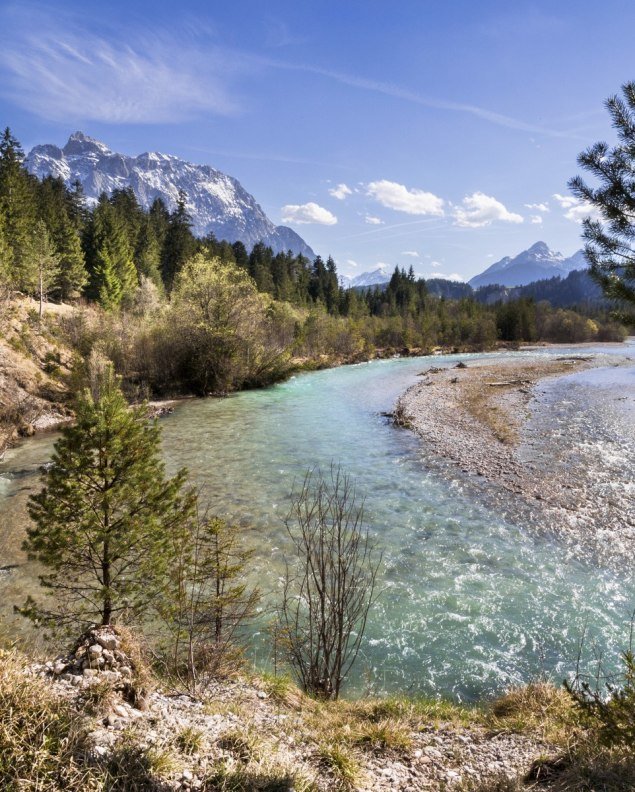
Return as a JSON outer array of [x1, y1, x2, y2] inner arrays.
[[0, 3, 245, 124]]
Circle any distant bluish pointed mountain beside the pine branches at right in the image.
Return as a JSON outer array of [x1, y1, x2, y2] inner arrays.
[[469, 242, 589, 289]]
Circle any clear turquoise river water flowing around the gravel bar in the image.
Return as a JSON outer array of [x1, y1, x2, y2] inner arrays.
[[0, 346, 634, 699]]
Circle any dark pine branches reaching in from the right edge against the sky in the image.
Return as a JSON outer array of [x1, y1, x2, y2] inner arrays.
[[569, 82, 635, 305]]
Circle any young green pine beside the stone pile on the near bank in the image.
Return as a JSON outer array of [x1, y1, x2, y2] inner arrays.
[[23, 361, 194, 625]]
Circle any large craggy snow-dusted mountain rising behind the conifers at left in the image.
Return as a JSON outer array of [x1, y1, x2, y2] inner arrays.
[[25, 132, 315, 258]]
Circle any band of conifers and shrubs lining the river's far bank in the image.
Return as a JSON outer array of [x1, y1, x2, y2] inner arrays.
[[0, 129, 625, 395]]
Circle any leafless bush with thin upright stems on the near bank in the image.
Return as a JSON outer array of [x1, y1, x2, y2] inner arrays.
[[279, 466, 381, 699]]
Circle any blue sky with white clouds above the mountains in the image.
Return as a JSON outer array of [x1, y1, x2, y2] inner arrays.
[[0, 0, 635, 280]]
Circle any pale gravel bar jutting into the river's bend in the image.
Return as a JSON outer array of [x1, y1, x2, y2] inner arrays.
[[395, 350, 635, 563]]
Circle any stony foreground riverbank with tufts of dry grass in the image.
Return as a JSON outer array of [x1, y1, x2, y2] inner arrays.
[[0, 627, 596, 792]]
